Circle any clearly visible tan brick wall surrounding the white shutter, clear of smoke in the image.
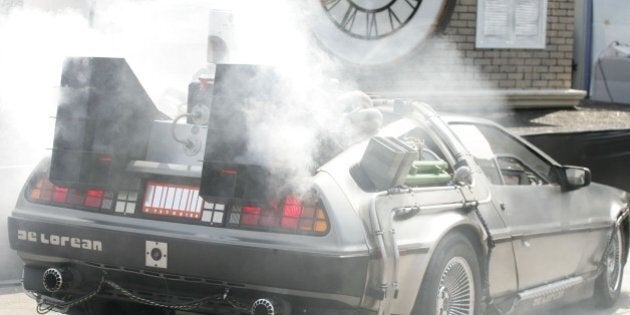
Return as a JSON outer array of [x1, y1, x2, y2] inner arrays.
[[445, 0, 574, 89]]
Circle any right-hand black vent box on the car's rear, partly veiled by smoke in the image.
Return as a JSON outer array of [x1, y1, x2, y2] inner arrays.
[[200, 64, 281, 200]]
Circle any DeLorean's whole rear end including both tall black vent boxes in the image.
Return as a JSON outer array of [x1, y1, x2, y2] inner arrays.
[[9, 58, 370, 314]]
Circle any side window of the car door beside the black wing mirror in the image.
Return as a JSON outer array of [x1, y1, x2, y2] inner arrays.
[[451, 124, 554, 185]]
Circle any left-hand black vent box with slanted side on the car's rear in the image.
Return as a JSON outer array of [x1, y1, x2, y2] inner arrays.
[[50, 57, 163, 188]]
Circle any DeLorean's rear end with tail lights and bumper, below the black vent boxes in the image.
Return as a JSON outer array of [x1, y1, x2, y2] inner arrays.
[[9, 159, 376, 313]]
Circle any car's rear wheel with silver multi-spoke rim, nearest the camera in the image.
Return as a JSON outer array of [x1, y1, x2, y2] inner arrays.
[[412, 233, 482, 315]]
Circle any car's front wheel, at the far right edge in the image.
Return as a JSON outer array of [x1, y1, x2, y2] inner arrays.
[[593, 228, 623, 308]]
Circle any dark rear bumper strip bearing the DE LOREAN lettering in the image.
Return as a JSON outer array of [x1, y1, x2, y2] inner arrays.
[[8, 218, 369, 297]]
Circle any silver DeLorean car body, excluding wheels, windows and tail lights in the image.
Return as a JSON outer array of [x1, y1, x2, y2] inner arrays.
[[9, 102, 628, 314]]
